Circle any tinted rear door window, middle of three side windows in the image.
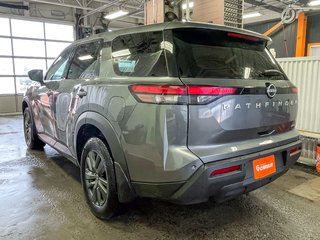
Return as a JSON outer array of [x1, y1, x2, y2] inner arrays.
[[67, 40, 101, 79]]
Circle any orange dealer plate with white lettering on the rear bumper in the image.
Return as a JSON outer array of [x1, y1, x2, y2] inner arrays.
[[252, 155, 277, 179]]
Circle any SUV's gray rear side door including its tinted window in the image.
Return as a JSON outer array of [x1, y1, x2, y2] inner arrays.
[[53, 40, 100, 148]]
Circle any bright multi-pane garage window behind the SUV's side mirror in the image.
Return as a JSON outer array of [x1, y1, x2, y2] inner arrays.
[[0, 17, 74, 95]]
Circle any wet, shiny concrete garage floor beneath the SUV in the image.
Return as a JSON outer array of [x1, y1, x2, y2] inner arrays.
[[0, 117, 320, 240]]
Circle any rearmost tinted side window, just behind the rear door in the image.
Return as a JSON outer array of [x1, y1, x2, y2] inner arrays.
[[112, 32, 168, 77]]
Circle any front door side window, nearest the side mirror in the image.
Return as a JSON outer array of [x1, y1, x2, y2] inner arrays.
[[45, 48, 72, 80]]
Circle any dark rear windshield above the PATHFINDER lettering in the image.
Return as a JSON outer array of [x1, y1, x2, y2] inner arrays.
[[172, 28, 287, 80]]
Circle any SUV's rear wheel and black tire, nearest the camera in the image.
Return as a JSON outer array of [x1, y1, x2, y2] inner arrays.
[[81, 137, 119, 219]]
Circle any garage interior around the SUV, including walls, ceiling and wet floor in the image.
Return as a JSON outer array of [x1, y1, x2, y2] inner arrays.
[[0, 0, 320, 239]]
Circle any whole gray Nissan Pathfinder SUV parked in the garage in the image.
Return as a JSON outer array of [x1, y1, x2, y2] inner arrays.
[[22, 22, 301, 219]]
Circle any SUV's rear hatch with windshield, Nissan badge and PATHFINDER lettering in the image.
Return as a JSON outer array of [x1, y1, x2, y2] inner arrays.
[[171, 28, 298, 162]]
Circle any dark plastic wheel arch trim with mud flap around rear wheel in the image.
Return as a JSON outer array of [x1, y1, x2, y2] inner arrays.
[[74, 112, 136, 202]]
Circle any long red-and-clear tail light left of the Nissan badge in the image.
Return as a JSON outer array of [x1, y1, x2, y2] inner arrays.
[[130, 85, 237, 104]]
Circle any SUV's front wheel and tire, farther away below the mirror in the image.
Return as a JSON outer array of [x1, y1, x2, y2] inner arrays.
[[23, 108, 45, 149]]
